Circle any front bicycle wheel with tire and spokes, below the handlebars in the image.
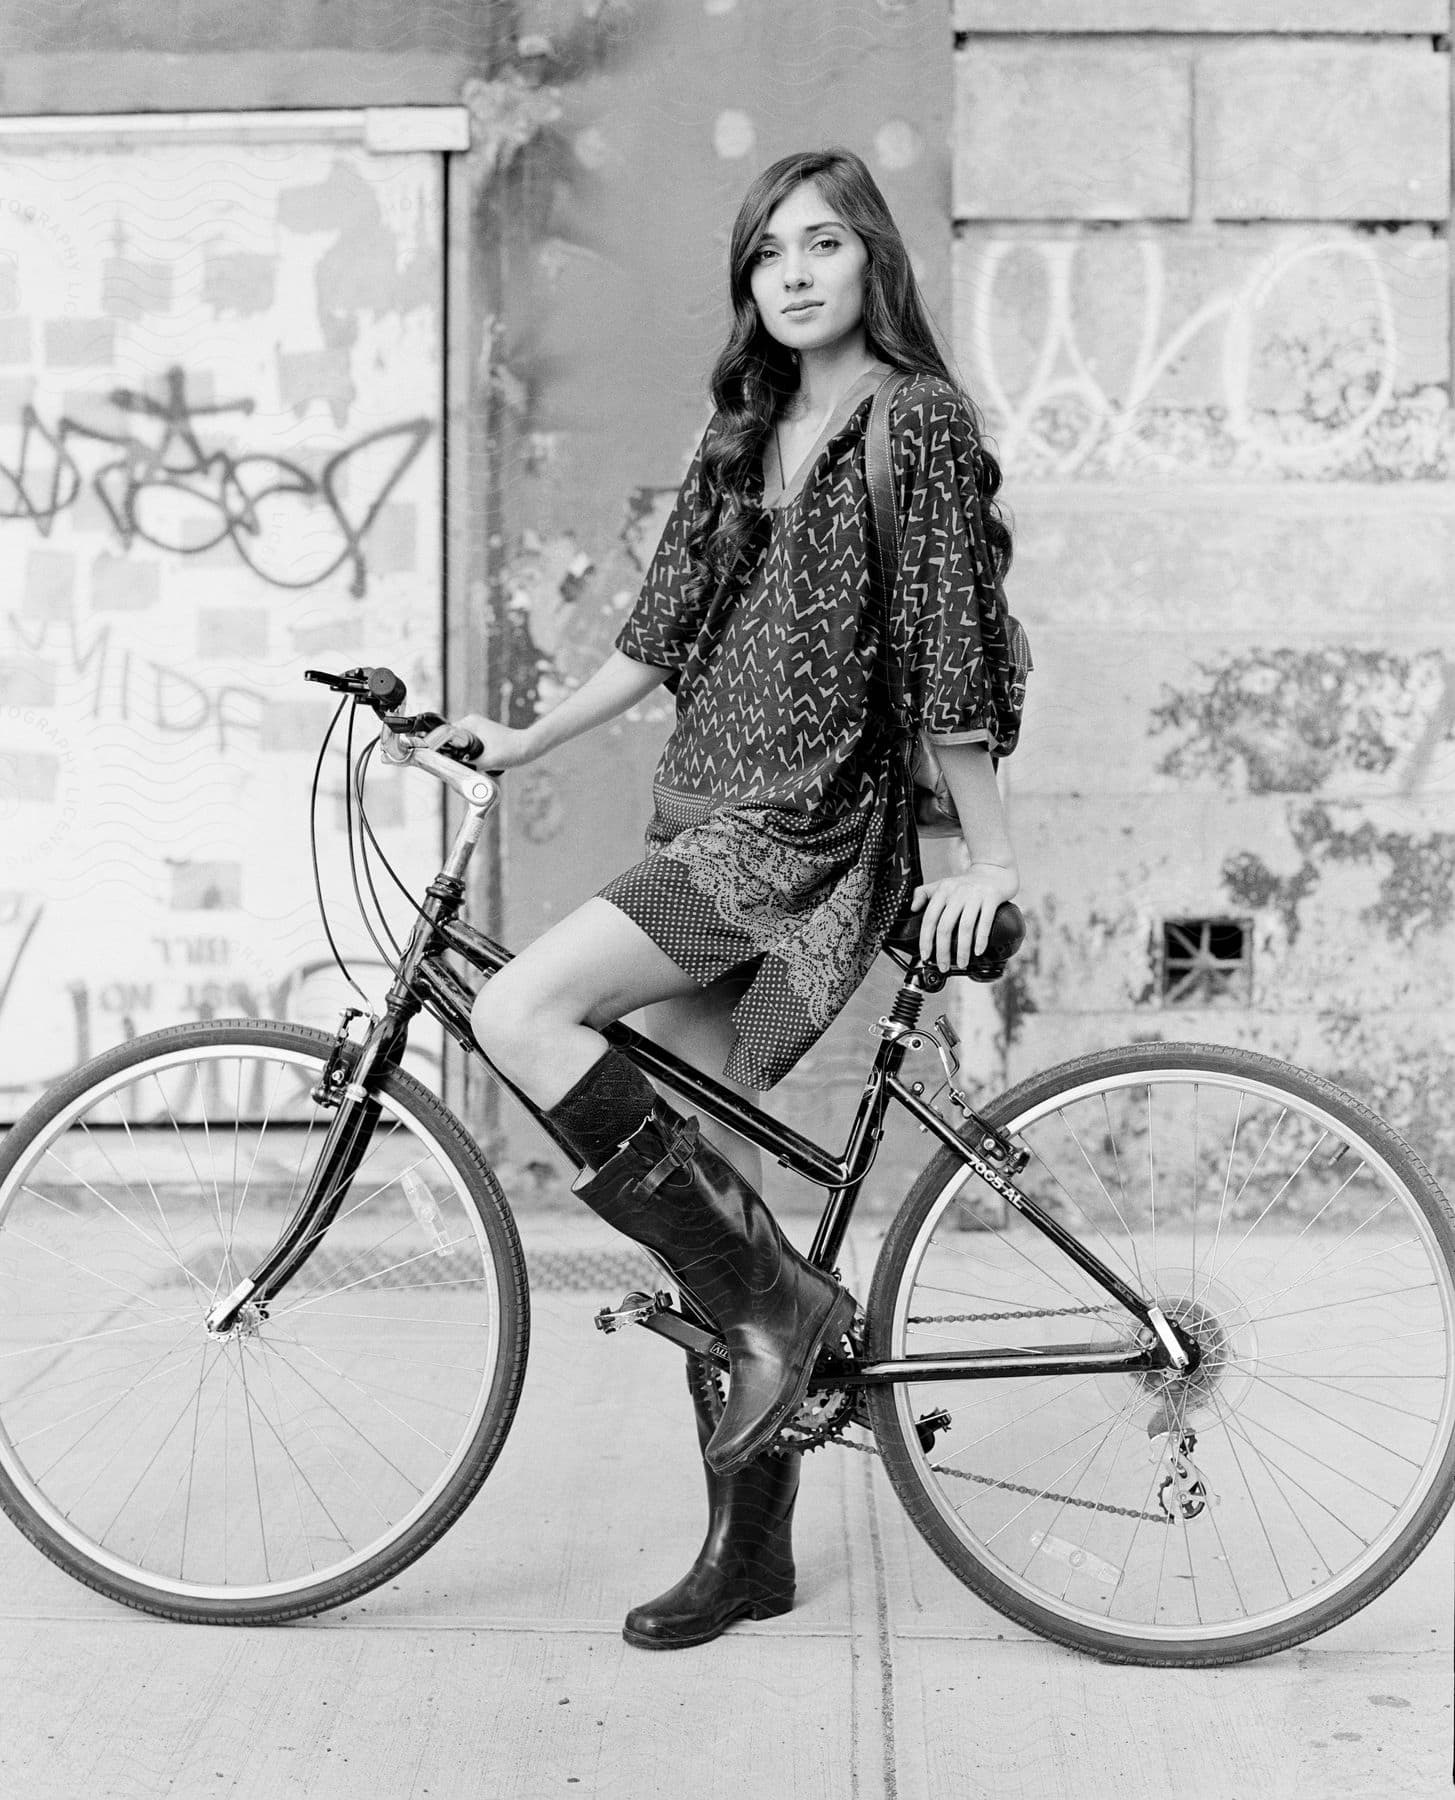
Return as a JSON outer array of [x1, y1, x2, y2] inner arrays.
[[0, 1019, 529, 1624]]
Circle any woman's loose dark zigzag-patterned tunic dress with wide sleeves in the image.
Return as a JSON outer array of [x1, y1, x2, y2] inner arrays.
[[601, 365, 1014, 1087]]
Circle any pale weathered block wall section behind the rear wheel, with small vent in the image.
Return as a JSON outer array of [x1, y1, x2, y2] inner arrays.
[[951, 10, 1455, 1177]]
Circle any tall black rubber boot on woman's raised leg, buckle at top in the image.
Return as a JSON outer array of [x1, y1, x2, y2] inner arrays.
[[547, 1049, 854, 1474]]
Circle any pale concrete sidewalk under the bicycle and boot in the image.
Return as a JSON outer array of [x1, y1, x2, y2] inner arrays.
[[0, 1217, 1455, 1800]]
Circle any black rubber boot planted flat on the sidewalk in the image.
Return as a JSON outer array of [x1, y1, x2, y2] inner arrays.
[[621, 1363, 803, 1651]]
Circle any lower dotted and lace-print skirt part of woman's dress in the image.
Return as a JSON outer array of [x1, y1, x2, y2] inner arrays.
[[600, 765, 906, 1089]]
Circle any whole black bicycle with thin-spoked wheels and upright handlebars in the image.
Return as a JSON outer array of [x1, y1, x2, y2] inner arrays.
[[0, 670, 1455, 1665]]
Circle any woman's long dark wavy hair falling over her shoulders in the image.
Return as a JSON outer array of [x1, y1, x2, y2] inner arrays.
[[686, 148, 1012, 598]]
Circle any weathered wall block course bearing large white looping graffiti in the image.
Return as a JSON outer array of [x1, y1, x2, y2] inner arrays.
[[962, 229, 1455, 479]]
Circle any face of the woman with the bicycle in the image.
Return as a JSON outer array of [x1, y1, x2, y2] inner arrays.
[[749, 182, 870, 365]]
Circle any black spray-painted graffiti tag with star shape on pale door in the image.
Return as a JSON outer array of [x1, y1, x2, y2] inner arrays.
[[0, 367, 434, 598]]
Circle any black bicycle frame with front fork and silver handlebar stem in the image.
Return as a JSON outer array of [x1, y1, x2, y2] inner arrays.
[[198, 751, 1196, 1388]]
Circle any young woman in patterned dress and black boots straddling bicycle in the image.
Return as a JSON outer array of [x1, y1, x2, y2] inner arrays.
[[442, 149, 1017, 1649]]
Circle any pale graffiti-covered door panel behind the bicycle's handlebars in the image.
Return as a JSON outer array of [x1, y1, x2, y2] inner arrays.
[[0, 140, 443, 1118]]
